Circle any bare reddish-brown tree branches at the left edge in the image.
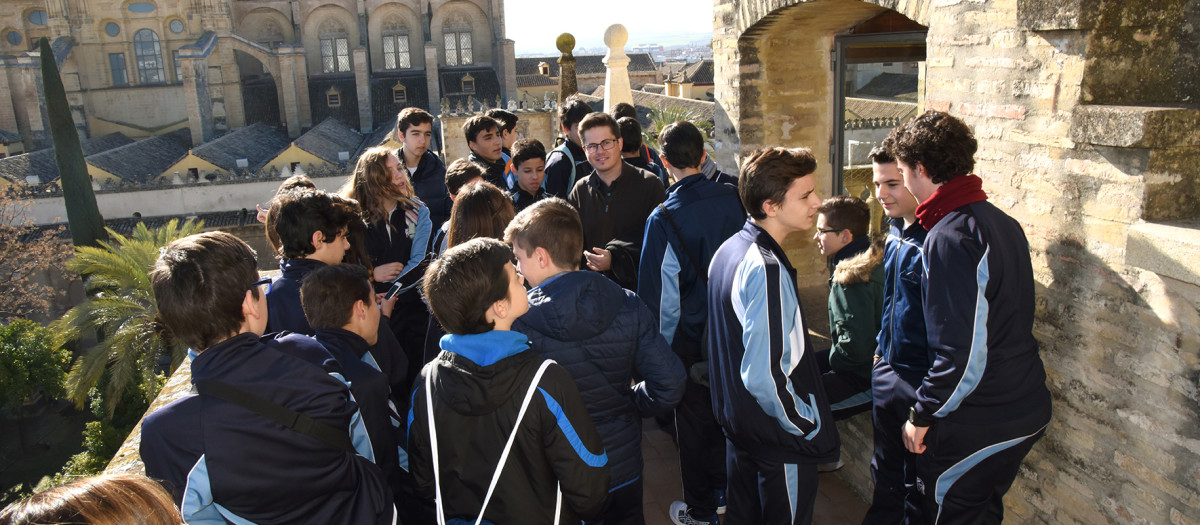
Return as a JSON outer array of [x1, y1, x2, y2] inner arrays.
[[0, 186, 71, 322]]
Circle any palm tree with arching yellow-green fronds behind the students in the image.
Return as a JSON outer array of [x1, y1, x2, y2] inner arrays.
[[52, 219, 203, 417]]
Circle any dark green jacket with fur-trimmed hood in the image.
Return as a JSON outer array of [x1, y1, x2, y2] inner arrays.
[[829, 242, 883, 378]]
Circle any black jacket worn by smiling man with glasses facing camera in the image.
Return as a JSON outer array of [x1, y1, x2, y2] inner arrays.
[[566, 162, 666, 290]]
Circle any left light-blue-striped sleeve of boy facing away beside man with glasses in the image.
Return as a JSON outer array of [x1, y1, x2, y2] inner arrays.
[[637, 211, 682, 344]]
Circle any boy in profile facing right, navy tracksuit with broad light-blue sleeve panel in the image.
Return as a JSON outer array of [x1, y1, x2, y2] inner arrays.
[[708, 147, 840, 525]]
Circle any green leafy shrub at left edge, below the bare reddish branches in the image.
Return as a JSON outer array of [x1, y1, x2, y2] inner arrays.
[[0, 319, 71, 410]]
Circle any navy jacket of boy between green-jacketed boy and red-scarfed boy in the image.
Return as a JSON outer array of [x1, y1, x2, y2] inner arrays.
[[877, 218, 934, 387]]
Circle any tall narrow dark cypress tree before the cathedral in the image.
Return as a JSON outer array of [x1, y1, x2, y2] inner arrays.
[[41, 37, 108, 247]]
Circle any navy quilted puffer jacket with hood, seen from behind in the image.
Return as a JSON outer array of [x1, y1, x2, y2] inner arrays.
[[512, 271, 686, 489]]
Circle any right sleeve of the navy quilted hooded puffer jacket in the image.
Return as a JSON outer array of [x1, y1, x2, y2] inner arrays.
[[630, 297, 688, 417]]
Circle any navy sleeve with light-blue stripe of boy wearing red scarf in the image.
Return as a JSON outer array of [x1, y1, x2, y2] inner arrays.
[[916, 230, 989, 418]]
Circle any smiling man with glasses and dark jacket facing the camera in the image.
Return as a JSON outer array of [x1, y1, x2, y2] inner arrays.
[[566, 113, 666, 290]]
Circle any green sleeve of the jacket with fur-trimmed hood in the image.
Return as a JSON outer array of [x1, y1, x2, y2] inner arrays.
[[829, 283, 880, 378]]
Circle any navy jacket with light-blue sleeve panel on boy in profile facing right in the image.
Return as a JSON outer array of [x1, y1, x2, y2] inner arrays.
[[708, 221, 840, 464]]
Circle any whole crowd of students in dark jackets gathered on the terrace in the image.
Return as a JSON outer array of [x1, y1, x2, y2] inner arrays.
[[72, 99, 1050, 525]]
